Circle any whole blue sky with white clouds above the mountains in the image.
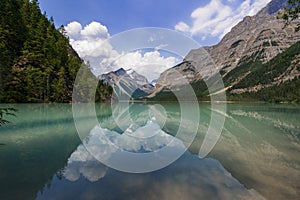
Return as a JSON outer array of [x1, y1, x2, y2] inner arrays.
[[40, 0, 270, 80]]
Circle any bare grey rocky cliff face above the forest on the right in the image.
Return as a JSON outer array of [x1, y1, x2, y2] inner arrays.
[[151, 0, 300, 100]]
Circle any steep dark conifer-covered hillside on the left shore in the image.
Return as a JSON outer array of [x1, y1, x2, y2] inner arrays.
[[0, 0, 111, 103]]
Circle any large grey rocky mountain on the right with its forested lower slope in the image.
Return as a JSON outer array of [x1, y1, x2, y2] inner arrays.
[[148, 0, 300, 101]]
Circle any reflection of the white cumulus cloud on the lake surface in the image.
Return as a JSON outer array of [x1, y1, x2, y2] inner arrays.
[[79, 118, 185, 161]]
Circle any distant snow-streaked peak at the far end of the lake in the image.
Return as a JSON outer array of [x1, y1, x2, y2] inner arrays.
[[98, 68, 154, 100]]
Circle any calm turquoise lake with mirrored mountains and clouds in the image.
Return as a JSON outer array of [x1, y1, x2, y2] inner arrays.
[[0, 103, 300, 199]]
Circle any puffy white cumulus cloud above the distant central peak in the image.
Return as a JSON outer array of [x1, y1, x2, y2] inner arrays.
[[65, 22, 178, 81]]
